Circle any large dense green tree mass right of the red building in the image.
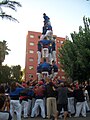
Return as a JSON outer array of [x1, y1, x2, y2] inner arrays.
[[59, 17, 90, 82]]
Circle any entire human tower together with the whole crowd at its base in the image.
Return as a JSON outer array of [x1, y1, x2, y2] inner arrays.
[[0, 13, 90, 120]]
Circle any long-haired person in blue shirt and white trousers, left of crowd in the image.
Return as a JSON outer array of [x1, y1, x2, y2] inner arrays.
[[10, 82, 24, 120]]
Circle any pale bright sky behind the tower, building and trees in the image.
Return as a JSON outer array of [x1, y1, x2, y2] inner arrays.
[[0, 0, 90, 68]]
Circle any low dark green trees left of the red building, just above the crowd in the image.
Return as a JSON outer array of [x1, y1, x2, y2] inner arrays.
[[0, 65, 21, 83]]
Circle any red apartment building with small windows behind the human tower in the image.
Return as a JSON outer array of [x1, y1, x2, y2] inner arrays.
[[25, 31, 65, 81]]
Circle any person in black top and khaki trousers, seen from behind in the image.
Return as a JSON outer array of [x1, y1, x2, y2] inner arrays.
[[45, 82, 57, 119]]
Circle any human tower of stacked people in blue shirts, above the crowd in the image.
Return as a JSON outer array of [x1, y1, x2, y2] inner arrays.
[[37, 13, 58, 80]]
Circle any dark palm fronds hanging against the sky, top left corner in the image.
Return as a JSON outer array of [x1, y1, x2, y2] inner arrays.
[[0, 0, 21, 22]]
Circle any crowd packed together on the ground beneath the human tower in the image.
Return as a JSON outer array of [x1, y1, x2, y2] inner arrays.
[[0, 77, 90, 120]]
